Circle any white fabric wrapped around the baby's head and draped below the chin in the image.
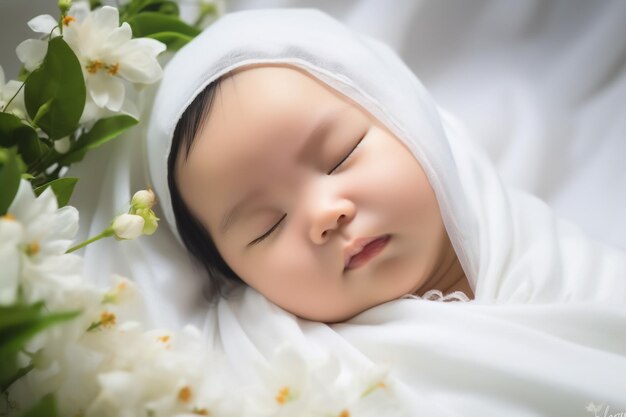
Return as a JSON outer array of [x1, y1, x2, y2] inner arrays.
[[68, 4, 626, 416]]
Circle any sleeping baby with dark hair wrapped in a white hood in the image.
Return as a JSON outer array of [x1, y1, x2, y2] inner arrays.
[[147, 9, 626, 322]]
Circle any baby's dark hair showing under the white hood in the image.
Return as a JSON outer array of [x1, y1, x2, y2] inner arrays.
[[167, 78, 243, 299]]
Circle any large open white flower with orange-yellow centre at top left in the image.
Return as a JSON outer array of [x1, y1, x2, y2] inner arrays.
[[63, 6, 165, 111]]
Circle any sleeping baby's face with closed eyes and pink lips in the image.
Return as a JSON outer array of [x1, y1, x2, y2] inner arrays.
[[176, 65, 451, 322]]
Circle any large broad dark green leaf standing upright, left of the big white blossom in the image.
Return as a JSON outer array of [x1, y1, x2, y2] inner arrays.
[[24, 37, 86, 140]]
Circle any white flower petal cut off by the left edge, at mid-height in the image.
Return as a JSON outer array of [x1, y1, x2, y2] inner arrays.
[[0, 215, 24, 305]]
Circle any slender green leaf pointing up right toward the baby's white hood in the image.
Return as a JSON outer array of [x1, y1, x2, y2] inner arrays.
[[59, 114, 138, 165]]
